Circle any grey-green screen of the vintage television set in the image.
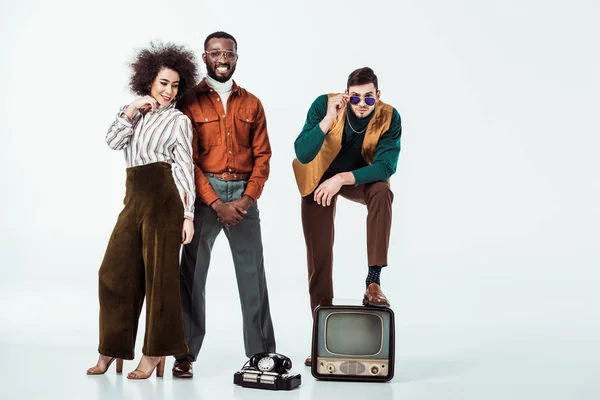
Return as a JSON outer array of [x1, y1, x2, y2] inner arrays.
[[325, 312, 383, 356]]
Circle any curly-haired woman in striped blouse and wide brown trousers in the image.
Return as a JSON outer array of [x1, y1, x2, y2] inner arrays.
[[87, 44, 198, 379]]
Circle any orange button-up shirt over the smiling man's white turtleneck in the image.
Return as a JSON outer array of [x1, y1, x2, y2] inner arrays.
[[177, 79, 271, 205]]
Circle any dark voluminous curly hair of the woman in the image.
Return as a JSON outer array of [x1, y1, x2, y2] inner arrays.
[[129, 43, 198, 98]]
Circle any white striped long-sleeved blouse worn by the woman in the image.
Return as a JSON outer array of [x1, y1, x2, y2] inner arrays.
[[106, 103, 196, 220]]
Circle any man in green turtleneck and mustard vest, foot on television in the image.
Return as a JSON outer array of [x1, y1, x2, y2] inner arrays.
[[293, 67, 402, 365]]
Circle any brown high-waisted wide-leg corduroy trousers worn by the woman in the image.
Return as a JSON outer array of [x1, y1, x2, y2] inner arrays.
[[98, 162, 188, 360]]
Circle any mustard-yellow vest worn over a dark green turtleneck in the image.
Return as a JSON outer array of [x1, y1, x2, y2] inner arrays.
[[292, 93, 393, 197]]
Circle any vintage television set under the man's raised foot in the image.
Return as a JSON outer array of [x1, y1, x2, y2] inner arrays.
[[311, 301, 395, 382]]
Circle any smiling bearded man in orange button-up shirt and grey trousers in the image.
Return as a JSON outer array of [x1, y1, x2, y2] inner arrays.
[[173, 32, 275, 378]]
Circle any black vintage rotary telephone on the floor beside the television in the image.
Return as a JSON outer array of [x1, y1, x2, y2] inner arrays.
[[233, 353, 301, 390]]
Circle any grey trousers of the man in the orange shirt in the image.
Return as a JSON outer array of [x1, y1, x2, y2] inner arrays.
[[176, 176, 275, 361]]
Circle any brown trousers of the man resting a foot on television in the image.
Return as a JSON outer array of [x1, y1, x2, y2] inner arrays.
[[302, 180, 394, 311]]
